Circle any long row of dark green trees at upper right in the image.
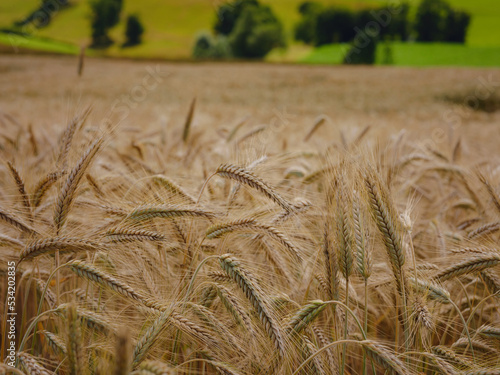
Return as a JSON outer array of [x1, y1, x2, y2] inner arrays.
[[295, 0, 471, 46]]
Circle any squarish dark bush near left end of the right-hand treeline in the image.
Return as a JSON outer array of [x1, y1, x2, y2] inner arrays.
[[315, 8, 355, 46]]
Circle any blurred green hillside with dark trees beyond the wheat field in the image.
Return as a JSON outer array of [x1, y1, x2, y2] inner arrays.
[[0, 0, 500, 66]]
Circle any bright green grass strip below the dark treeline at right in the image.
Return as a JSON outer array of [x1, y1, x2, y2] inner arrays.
[[299, 43, 500, 67]]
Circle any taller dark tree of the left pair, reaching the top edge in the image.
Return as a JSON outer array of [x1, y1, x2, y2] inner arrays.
[[90, 0, 123, 48]]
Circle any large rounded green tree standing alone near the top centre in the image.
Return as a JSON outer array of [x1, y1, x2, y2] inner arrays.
[[229, 5, 286, 58]]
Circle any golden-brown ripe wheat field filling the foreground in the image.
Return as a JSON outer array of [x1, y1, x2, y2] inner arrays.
[[0, 56, 500, 375]]
